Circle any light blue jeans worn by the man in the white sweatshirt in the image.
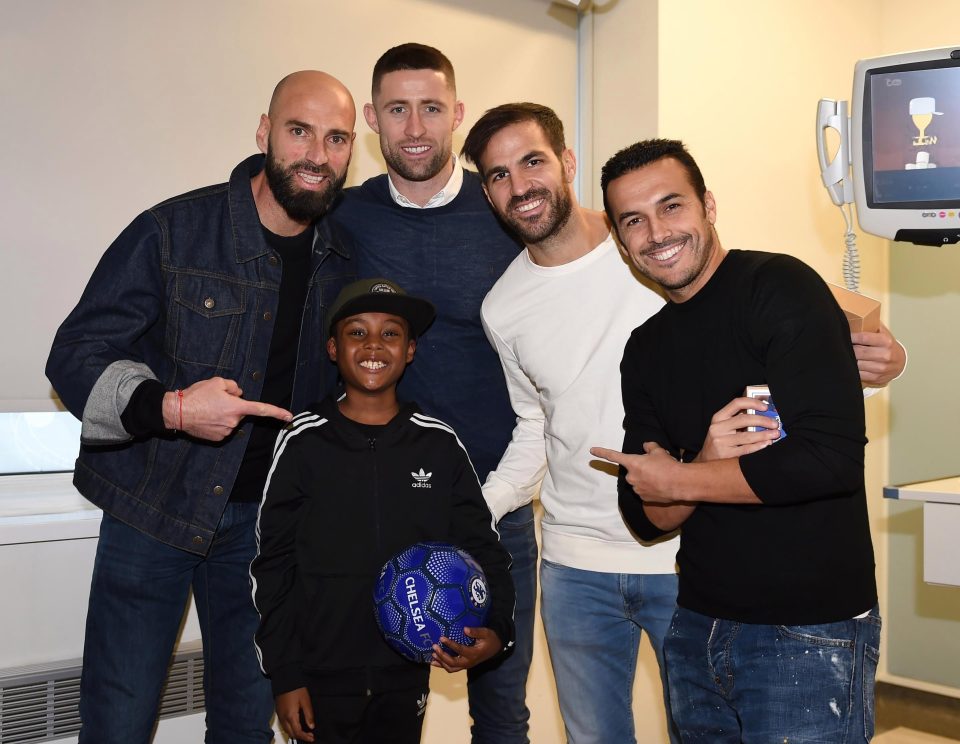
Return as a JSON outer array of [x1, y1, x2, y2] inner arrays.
[[540, 560, 679, 744]]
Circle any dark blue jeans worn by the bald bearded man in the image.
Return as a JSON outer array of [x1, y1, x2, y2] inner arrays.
[[80, 503, 273, 744]]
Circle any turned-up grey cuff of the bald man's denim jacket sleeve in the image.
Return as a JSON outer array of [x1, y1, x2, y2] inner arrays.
[[80, 359, 157, 444]]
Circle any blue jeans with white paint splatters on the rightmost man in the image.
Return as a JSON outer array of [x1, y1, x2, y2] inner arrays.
[[664, 608, 880, 744]]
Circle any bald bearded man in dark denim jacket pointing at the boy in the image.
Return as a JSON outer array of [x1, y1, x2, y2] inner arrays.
[[47, 71, 356, 744]]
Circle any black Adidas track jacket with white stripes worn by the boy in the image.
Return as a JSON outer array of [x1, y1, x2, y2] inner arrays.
[[250, 398, 515, 695]]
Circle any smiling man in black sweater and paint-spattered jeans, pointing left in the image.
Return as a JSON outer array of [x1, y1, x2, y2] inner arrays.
[[591, 140, 880, 744]]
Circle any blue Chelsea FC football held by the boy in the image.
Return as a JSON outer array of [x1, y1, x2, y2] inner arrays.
[[373, 542, 490, 662]]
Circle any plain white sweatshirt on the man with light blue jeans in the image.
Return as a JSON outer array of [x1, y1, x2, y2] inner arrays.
[[481, 236, 679, 574]]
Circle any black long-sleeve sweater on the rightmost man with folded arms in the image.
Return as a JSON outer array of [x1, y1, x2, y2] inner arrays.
[[619, 251, 877, 625]]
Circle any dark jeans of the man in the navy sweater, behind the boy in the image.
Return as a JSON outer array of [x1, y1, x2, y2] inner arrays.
[[467, 504, 537, 744]]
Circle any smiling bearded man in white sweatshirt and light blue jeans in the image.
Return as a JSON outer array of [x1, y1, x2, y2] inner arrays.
[[463, 103, 678, 744]]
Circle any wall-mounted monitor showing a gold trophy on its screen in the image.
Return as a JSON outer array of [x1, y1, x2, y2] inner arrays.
[[850, 44, 960, 245]]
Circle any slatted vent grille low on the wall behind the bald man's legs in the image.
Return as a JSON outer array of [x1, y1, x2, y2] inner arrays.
[[0, 641, 203, 744]]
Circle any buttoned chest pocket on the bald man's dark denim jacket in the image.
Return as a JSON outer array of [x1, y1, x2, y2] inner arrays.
[[167, 274, 248, 372]]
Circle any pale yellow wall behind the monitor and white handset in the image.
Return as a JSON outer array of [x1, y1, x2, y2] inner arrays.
[[657, 0, 960, 694]]
